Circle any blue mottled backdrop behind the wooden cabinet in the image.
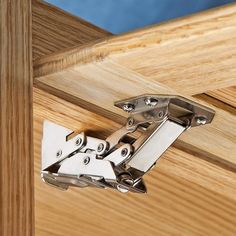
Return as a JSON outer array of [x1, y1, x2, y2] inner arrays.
[[47, 0, 236, 34]]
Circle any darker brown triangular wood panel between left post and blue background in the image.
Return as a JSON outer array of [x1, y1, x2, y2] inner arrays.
[[32, 0, 111, 59]]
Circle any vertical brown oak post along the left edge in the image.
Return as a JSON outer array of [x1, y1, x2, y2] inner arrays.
[[0, 0, 34, 236]]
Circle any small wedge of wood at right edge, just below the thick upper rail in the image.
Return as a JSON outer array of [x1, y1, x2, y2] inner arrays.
[[207, 86, 236, 108]]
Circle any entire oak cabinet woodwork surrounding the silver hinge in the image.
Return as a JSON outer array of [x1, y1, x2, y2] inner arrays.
[[0, 0, 236, 236]]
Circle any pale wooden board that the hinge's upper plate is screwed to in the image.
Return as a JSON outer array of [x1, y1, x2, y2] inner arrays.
[[35, 59, 236, 168]]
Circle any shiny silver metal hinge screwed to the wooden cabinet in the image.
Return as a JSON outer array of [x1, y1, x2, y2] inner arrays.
[[41, 95, 215, 193]]
